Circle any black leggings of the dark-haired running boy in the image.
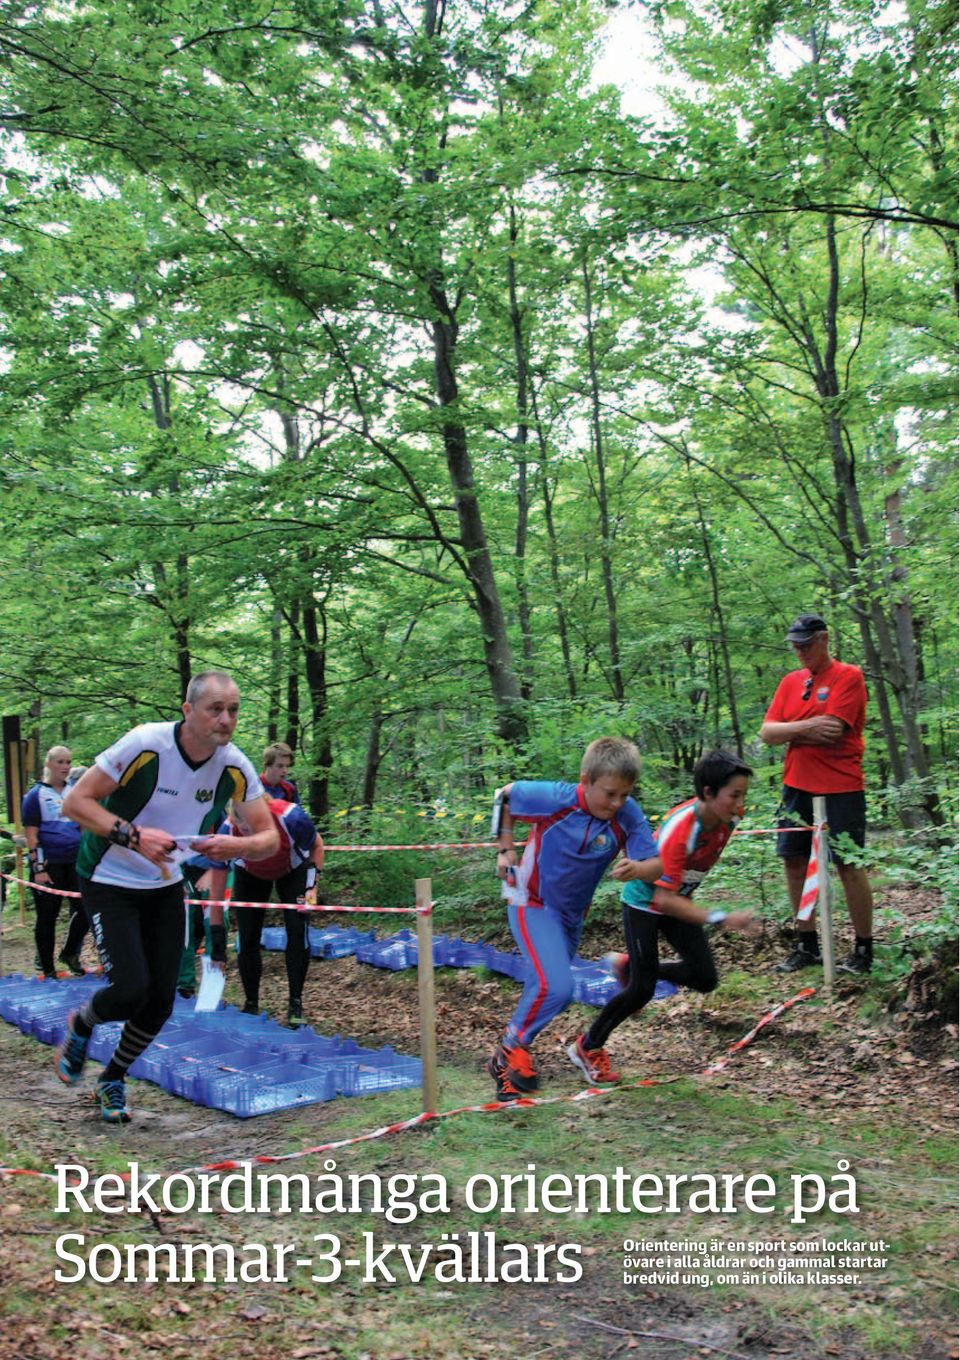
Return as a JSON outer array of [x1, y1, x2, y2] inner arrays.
[[583, 903, 718, 1049]]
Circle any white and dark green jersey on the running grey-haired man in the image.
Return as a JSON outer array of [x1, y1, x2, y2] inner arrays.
[[76, 722, 264, 888]]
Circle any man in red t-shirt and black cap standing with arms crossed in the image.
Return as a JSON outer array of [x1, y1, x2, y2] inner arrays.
[[760, 613, 873, 972]]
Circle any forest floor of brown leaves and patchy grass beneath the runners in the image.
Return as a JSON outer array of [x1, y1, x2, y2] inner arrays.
[[0, 889, 960, 1360]]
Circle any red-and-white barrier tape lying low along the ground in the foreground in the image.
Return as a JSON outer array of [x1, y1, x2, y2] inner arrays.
[[0, 987, 816, 1180]]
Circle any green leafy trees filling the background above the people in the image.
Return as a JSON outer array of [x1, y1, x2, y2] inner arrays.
[[0, 0, 959, 835]]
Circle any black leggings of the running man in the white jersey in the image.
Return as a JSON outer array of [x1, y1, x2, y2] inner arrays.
[[80, 879, 184, 1035]]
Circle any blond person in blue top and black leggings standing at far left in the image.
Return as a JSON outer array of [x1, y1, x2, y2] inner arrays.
[[20, 747, 88, 978]]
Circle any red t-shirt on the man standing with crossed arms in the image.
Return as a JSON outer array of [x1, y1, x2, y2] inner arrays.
[[764, 661, 866, 793]]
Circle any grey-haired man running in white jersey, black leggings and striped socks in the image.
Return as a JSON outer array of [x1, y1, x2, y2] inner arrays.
[[57, 670, 279, 1123]]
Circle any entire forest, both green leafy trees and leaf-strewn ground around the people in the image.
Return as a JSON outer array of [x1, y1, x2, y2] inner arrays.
[[0, 13, 960, 1360]]
